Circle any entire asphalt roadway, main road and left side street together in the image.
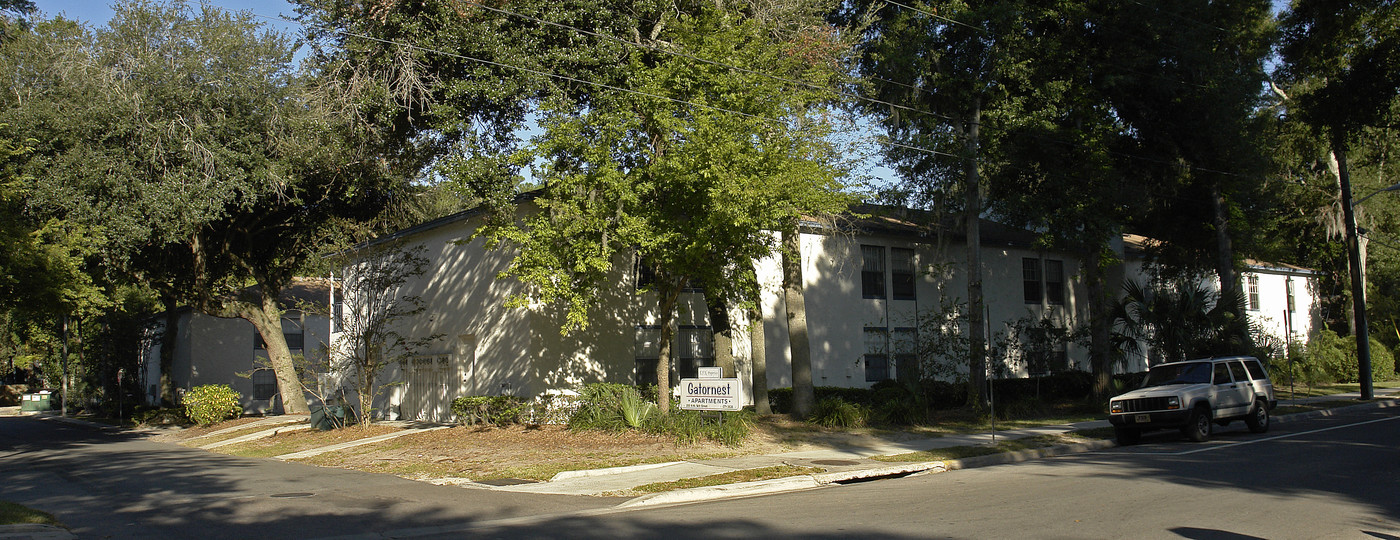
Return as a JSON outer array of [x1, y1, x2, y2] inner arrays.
[[0, 407, 1400, 540]]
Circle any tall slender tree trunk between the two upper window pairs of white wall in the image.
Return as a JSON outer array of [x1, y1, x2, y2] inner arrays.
[[963, 98, 987, 408]]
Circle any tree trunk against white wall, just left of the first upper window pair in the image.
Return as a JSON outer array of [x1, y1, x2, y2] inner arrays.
[[783, 224, 816, 420]]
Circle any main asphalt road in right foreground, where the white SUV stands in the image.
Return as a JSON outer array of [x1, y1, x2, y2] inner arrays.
[[420, 408, 1400, 540]]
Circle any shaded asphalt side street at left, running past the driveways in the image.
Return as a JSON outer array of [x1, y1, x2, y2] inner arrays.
[[0, 417, 623, 540]]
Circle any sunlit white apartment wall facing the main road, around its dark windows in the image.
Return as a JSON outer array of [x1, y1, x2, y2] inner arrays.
[[759, 225, 1088, 388]]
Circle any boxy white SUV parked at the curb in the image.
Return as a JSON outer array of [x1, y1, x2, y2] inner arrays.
[[1109, 357, 1278, 445]]
